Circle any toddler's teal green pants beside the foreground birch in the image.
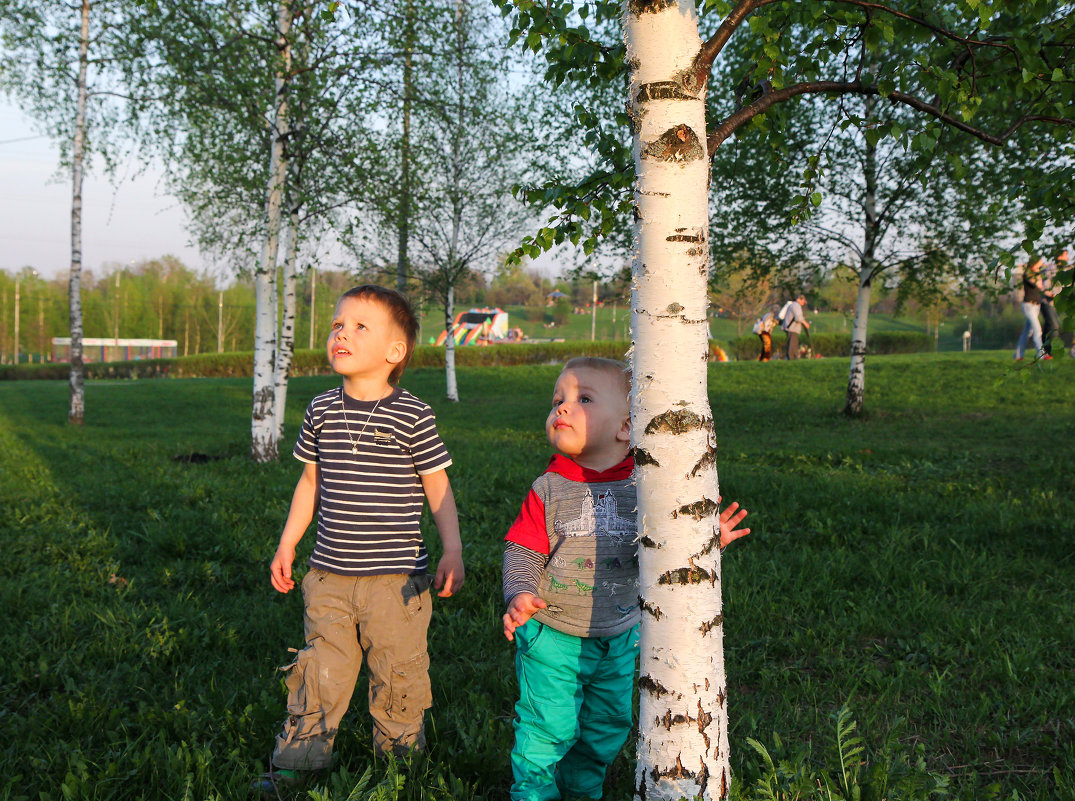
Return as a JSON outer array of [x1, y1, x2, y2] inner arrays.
[[511, 619, 639, 801]]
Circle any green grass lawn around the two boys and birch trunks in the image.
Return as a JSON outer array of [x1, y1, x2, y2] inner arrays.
[[0, 353, 1075, 801]]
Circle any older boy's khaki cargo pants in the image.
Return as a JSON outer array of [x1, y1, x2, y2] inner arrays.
[[272, 569, 432, 770]]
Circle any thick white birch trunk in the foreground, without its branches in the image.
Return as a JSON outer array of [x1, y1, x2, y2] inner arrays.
[[624, 0, 730, 801]]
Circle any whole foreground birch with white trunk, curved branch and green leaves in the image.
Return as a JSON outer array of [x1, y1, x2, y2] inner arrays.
[[501, 0, 1075, 800]]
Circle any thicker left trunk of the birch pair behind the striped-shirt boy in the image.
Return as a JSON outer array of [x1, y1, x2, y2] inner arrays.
[[250, 0, 292, 462]]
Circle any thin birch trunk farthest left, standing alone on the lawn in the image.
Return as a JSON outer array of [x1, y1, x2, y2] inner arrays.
[[67, 0, 89, 426]]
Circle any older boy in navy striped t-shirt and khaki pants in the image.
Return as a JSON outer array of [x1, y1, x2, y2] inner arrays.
[[254, 285, 464, 797]]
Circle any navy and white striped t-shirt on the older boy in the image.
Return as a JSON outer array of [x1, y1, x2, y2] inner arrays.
[[293, 387, 452, 575]]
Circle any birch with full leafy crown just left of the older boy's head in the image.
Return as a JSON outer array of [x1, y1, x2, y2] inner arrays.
[[133, 0, 381, 462]]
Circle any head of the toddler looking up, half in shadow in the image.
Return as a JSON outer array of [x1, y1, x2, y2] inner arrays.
[[545, 367, 631, 470]]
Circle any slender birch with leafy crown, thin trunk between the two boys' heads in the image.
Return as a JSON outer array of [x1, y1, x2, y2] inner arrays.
[[352, 0, 544, 400]]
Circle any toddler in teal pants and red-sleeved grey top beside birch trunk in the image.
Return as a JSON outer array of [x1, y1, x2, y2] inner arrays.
[[502, 357, 750, 801]]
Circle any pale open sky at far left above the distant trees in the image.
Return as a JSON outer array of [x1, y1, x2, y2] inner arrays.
[[0, 101, 207, 278]]
